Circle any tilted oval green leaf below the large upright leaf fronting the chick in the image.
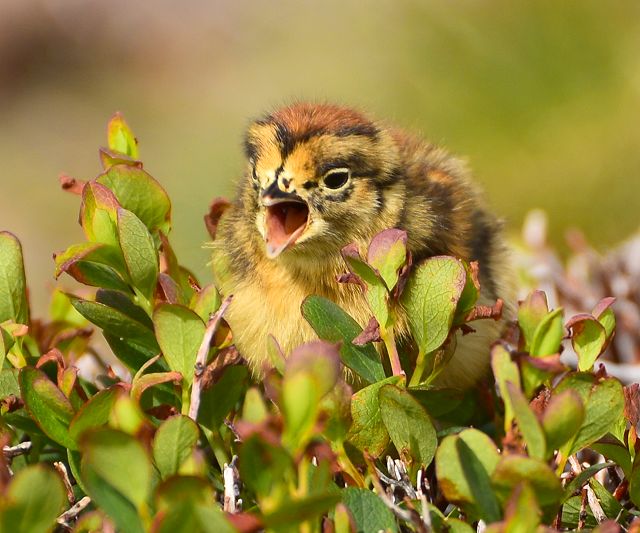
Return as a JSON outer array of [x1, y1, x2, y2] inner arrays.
[[378, 385, 438, 467]]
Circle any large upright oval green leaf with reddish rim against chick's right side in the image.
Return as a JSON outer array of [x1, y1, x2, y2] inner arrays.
[[401, 256, 466, 354]]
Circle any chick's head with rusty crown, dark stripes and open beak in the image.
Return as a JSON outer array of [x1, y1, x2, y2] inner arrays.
[[243, 104, 398, 259]]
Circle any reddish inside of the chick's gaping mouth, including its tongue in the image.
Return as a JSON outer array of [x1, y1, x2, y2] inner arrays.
[[266, 202, 309, 259]]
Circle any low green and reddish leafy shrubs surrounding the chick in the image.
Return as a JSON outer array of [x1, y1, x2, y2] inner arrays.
[[0, 115, 640, 532]]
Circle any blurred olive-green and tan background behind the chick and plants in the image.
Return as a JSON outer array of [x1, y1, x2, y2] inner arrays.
[[0, 0, 640, 312]]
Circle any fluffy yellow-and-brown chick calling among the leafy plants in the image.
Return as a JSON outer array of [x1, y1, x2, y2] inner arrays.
[[213, 103, 512, 388]]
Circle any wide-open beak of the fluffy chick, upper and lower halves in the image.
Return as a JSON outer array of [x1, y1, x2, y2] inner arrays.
[[262, 193, 309, 259]]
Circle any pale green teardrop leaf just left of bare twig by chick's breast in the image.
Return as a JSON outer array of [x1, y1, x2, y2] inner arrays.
[[153, 304, 206, 386]]
